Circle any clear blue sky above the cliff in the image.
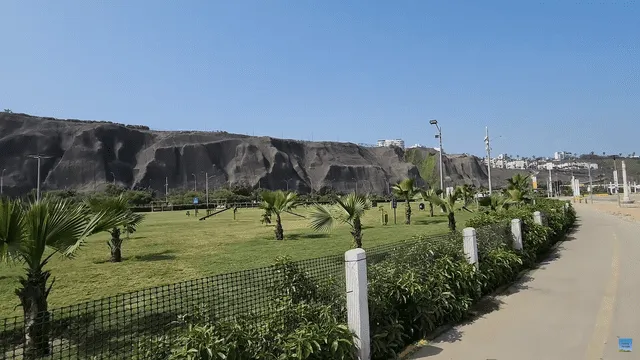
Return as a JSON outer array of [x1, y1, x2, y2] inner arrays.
[[0, 0, 640, 156]]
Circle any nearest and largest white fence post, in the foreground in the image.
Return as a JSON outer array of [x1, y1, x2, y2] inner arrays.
[[344, 248, 371, 360]]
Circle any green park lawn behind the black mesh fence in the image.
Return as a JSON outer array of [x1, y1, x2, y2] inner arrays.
[[0, 204, 472, 318]]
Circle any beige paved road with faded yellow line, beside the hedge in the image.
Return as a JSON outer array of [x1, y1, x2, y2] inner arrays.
[[411, 204, 640, 360]]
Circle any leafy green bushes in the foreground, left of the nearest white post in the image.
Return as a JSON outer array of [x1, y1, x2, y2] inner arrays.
[[135, 258, 356, 360]]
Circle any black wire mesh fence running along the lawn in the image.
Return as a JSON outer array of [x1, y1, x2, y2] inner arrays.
[[0, 233, 470, 360]]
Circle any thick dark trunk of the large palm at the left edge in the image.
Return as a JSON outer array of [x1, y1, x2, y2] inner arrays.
[[16, 269, 53, 360]]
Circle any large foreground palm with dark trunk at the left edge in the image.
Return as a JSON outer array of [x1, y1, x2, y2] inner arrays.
[[0, 197, 126, 359]]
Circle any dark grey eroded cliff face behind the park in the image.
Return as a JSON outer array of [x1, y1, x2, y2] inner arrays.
[[0, 113, 430, 195]]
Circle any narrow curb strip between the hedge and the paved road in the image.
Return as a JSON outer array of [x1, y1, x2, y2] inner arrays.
[[398, 232, 575, 360]]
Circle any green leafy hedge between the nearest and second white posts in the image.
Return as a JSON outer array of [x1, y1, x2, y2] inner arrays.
[[368, 234, 482, 359]]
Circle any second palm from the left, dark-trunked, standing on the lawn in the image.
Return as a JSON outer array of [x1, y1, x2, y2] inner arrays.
[[87, 195, 144, 262]]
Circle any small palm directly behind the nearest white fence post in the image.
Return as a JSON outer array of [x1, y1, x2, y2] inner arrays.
[[310, 193, 371, 248]]
